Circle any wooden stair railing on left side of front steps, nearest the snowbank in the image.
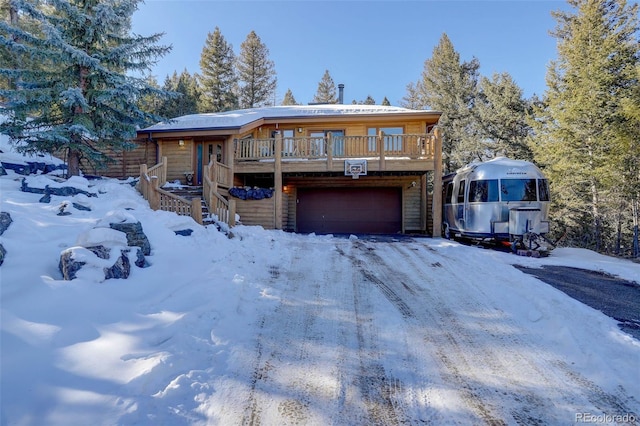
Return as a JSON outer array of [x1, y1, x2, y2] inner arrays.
[[138, 157, 202, 224]]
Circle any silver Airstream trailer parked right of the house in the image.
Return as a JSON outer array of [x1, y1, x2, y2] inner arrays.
[[442, 157, 550, 251]]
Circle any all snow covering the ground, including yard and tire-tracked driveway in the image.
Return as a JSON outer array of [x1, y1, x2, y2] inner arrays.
[[0, 138, 640, 426]]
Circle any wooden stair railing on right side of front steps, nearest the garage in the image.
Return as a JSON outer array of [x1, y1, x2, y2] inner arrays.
[[202, 160, 236, 226]]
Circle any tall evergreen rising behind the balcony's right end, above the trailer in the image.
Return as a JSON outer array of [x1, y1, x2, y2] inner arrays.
[[414, 34, 486, 172]]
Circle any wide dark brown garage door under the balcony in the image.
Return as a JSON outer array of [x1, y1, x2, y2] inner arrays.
[[296, 188, 402, 234]]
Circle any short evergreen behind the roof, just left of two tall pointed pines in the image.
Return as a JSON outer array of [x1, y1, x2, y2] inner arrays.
[[158, 69, 199, 118]]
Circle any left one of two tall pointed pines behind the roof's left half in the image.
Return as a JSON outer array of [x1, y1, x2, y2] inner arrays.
[[200, 27, 238, 112]]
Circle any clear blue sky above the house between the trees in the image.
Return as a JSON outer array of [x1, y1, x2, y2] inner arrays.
[[133, 0, 569, 105]]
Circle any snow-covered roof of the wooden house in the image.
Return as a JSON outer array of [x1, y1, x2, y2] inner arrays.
[[141, 104, 435, 132]]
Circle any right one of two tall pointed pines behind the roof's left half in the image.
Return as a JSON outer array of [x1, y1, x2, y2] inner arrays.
[[237, 31, 277, 108]]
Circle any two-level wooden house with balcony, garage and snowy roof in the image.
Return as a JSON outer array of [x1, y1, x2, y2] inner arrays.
[[132, 104, 442, 236]]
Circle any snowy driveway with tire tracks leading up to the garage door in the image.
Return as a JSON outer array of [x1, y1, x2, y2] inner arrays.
[[204, 238, 640, 425]]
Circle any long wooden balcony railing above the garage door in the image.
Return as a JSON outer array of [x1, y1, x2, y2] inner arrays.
[[235, 133, 435, 161]]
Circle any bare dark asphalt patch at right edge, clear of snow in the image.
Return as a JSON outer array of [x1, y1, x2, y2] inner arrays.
[[514, 265, 640, 340]]
